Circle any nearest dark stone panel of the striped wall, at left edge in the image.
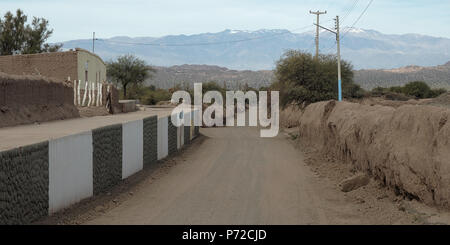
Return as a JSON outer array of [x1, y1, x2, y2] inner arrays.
[[0, 142, 49, 224]]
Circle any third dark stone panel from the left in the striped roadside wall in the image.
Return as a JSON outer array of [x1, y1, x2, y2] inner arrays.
[[144, 116, 158, 167]]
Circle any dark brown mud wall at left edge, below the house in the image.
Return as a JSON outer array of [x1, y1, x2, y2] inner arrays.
[[0, 73, 79, 127]]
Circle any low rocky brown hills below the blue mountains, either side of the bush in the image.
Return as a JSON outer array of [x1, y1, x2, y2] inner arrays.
[[146, 62, 450, 90]]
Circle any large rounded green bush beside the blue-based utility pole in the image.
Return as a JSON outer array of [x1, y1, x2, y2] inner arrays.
[[270, 50, 365, 106]]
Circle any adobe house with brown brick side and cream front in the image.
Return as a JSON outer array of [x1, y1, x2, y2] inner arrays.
[[0, 48, 106, 87]]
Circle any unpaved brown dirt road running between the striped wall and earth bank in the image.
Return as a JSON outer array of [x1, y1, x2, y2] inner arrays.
[[69, 127, 446, 224]]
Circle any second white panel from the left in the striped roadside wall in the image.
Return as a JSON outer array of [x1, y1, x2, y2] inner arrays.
[[122, 120, 144, 179]]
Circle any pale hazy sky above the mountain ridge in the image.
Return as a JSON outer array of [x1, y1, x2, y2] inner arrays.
[[0, 0, 450, 42]]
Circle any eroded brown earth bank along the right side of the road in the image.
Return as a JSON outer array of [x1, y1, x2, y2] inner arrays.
[[299, 101, 450, 208]]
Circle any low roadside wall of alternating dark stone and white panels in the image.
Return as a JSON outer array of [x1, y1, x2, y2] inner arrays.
[[0, 111, 198, 224]]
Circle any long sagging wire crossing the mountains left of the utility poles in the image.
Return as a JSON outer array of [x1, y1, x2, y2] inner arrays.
[[98, 25, 312, 47]]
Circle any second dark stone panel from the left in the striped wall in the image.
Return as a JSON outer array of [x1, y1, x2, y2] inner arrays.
[[92, 124, 122, 195]]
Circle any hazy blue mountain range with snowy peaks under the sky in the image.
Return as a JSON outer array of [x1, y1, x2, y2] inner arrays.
[[63, 29, 450, 70]]
